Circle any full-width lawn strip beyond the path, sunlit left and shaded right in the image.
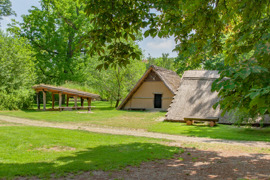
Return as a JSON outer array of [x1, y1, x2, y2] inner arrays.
[[0, 101, 270, 142]]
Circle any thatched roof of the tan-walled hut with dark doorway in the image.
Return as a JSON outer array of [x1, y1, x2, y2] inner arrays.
[[117, 65, 181, 109]]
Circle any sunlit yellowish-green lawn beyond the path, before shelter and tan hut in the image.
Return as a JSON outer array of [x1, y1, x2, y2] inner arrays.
[[0, 101, 165, 129]]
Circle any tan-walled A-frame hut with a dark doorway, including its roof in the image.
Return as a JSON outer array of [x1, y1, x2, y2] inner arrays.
[[117, 65, 181, 111]]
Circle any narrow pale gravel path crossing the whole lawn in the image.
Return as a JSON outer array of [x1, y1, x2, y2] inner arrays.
[[0, 115, 270, 148]]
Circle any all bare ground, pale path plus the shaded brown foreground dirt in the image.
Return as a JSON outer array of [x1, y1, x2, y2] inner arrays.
[[0, 116, 270, 180]]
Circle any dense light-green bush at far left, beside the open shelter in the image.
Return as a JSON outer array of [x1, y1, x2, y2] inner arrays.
[[0, 32, 36, 110]]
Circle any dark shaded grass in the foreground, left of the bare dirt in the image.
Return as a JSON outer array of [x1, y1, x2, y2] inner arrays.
[[0, 143, 179, 178]]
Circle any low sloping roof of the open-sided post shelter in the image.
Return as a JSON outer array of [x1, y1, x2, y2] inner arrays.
[[32, 84, 100, 99]]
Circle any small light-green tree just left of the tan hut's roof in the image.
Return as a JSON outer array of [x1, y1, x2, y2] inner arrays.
[[87, 59, 146, 107]]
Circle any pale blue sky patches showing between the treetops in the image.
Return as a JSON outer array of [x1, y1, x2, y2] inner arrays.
[[1, 0, 177, 57]]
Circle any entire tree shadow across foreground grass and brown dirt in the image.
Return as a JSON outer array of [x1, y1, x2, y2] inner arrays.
[[0, 146, 270, 179]]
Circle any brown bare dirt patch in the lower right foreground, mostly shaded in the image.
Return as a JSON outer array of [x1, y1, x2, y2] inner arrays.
[[56, 148, 270, 180]]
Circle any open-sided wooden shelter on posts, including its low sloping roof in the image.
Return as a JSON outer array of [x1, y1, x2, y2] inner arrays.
[[32, 84, 100, 111]]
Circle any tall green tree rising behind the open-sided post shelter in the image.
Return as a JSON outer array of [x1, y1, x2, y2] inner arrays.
[[9, 0, 92, 84]]
